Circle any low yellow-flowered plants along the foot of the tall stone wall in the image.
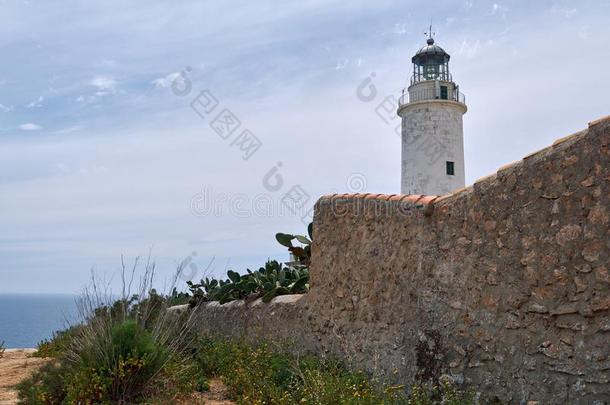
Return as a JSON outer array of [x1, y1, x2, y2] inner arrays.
[[195, 338, 474, 405]]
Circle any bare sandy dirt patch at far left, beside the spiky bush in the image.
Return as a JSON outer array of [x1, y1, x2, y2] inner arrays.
[[0, 349, 47, 405]]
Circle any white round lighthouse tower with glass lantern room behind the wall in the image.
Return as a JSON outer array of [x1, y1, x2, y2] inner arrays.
[[398, 33, 467, 195]]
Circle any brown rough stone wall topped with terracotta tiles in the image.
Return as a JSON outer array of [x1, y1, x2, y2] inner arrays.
[[191, 118, 610, 404]]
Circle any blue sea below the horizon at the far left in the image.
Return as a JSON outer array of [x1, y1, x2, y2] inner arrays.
[[0, 294, 77, 348]]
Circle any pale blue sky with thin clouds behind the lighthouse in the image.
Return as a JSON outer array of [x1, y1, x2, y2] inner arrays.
[[0, 0, 610, 293]]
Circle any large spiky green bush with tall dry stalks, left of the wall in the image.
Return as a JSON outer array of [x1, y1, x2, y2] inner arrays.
[[19, 258, 205, 404]]
